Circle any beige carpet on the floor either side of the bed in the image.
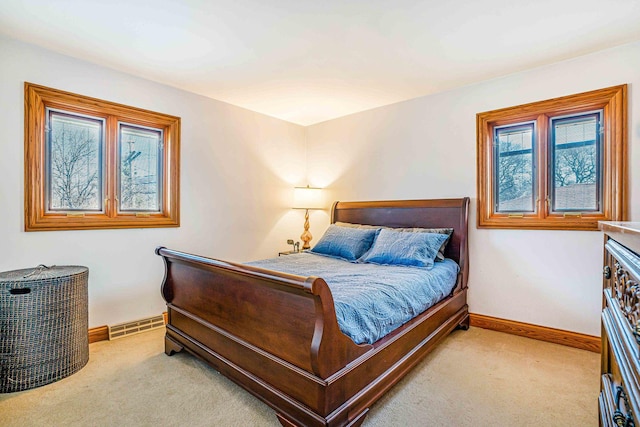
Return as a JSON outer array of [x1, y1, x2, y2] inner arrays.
[[0, 328, 600, 427]]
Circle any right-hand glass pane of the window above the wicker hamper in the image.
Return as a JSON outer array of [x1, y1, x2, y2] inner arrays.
[[119, 124, 162, 212]]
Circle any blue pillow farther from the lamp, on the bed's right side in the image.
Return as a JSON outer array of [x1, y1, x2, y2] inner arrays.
[[358, 229, 449, 268]]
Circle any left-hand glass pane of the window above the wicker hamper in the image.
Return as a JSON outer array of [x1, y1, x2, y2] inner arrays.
[[46, 109, 104, 211]]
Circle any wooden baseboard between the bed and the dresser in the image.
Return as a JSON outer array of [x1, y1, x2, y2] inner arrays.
[[469, 313, 601, 353]]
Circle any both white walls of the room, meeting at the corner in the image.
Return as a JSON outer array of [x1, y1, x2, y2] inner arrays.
[[0, 37, 640, 335]]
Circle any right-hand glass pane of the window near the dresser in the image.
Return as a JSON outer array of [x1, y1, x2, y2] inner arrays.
[[551, 112, 601, 211]]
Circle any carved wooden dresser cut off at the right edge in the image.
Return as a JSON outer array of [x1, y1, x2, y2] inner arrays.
[[599, 222, 640, 427]]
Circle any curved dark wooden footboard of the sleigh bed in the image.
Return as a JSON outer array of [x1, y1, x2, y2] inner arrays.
[[156, 247, 373, 424]]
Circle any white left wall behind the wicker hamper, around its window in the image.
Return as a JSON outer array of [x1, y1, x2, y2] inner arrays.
[[0, 37, 306, 327]]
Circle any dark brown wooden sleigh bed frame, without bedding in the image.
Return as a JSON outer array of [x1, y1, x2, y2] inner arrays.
[[156, 198, 469, 426]]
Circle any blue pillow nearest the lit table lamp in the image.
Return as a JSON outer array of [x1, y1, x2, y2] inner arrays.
[[311, 224, 378, 261]]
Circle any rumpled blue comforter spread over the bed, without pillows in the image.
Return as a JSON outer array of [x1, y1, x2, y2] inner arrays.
[[247, 252, 459, 344]]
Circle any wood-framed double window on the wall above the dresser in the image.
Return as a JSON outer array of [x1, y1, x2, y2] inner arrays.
[[477, 85, 627, 230]]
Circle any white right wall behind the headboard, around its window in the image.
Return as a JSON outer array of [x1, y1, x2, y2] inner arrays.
[[307, 43, 640, 335]]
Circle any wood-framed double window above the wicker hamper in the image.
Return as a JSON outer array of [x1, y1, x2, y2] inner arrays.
[[25, 83, 180, 231]]
